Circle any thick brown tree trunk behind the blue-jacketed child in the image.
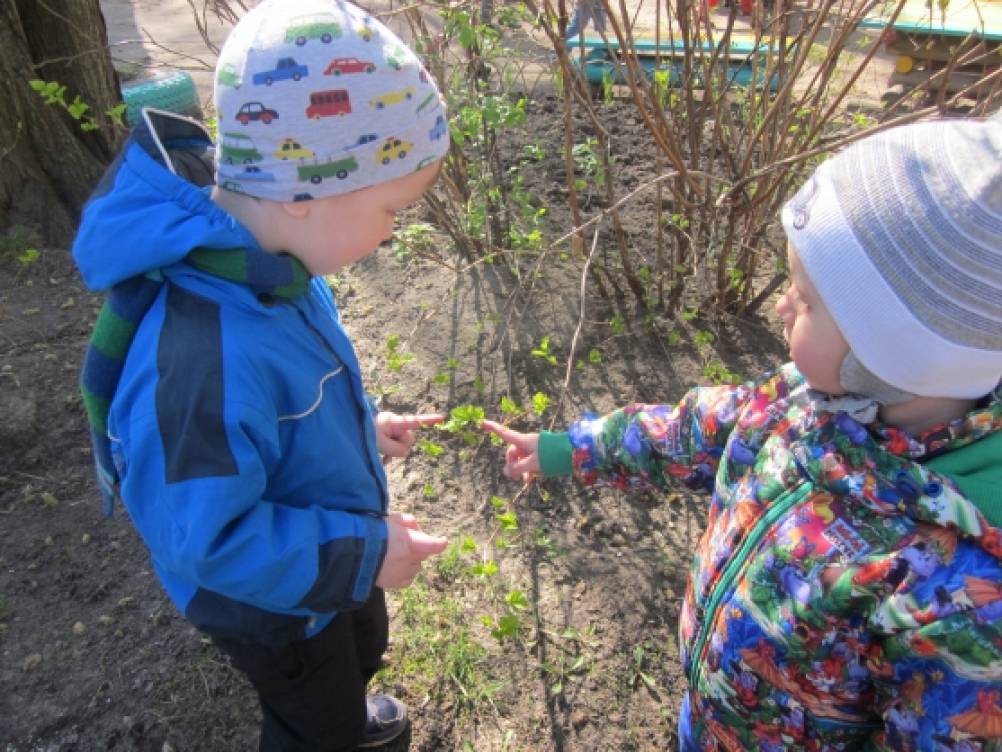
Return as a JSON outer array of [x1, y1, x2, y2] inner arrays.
[[0, 0, 124, 248]]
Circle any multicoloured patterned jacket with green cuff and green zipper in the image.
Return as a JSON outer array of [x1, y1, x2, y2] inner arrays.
[[540, 365, 1002, 751]]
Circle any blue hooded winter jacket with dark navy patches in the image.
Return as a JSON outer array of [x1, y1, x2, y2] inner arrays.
[[73, 111, 388, 645]]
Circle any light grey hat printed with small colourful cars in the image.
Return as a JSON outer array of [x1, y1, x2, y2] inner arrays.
[[215, 0, 449, 202]]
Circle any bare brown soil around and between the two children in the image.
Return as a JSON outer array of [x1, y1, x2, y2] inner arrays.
[[0, 91, 784, 752]]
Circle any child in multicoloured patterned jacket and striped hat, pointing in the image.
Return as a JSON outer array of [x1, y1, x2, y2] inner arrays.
[[485, 118, 1002, 751]]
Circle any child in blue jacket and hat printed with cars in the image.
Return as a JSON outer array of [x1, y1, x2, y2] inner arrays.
[[74, 0, 449, 752]]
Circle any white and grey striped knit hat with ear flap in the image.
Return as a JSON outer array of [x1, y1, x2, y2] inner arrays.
[[782, 117, 1002, 398]]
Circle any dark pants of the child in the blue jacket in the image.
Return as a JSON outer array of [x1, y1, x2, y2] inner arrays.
[[213, 589, 389, 752]]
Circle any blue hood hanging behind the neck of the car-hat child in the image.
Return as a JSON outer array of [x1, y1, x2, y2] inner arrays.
[[73, 108, 258, 290]]
